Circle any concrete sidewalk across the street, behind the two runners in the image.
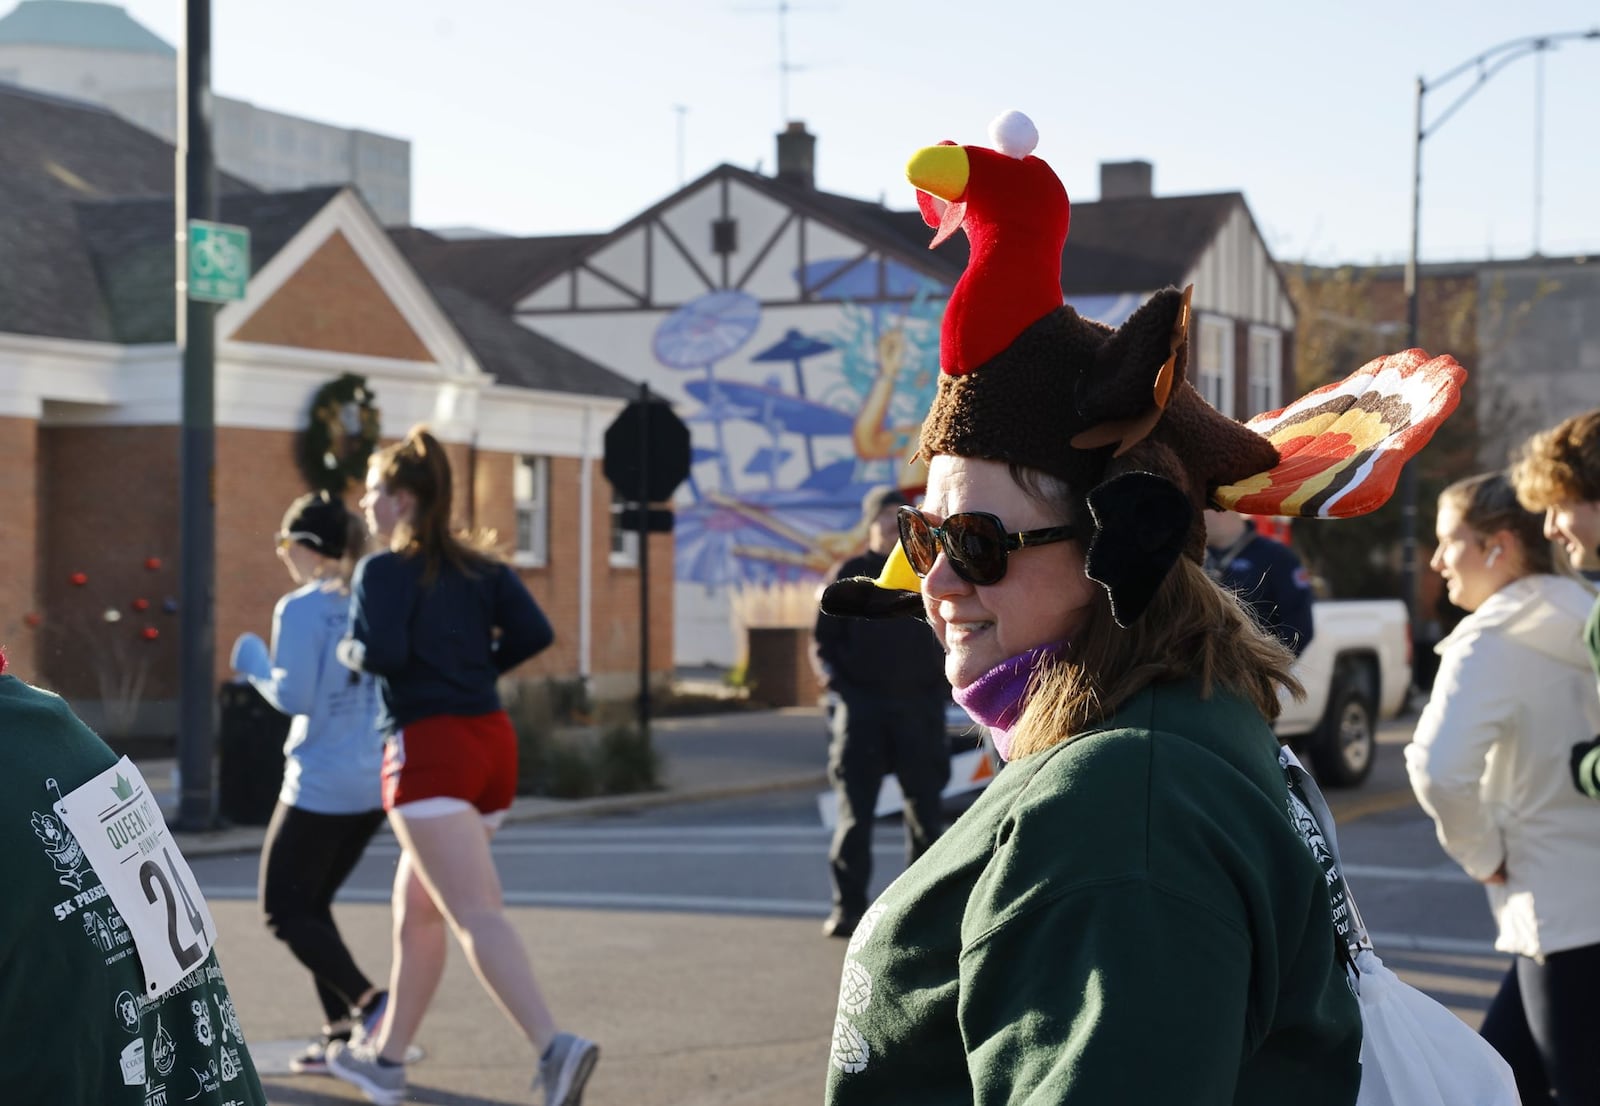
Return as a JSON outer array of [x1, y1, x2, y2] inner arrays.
[[152, 707, 827, 856]]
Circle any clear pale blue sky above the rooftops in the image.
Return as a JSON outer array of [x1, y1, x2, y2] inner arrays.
[[116, 0, 1600, 262]]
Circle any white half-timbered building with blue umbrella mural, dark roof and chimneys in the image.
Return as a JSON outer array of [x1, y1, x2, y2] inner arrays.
[[400, 125, 1294, 664]]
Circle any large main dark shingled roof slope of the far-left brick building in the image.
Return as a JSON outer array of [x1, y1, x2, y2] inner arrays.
[[0, 83, 254, 341]]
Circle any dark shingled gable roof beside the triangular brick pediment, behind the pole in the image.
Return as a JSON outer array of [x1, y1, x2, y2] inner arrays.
[[75, 186, 341, 344]]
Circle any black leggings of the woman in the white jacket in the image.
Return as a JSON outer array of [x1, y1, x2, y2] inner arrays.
[[1480, 944, 1600, 1106]]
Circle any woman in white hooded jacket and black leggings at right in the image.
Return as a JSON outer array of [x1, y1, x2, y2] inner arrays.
[[1405, 472, 1600, 1106]]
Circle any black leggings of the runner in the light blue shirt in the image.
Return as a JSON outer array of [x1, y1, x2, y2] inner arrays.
[[261, 802, 384, 1024]]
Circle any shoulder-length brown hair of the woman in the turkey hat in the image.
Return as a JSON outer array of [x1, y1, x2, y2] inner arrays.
[[1011, 466, 1304, 755]]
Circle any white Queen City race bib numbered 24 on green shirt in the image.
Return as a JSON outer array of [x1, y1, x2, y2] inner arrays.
[[56, 757, 216, 999]]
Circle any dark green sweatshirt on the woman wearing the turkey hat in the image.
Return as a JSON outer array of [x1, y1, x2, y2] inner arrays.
[[827, 683, 1362, 1106]]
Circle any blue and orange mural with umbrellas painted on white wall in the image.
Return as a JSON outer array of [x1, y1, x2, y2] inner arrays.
[[651, 258, 949, 592]]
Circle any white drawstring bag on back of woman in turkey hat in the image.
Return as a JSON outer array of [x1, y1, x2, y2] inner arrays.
[[1278, 749, 1522, 1106]]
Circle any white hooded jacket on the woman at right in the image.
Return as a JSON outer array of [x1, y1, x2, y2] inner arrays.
[[1405, 575, 1600, 957]]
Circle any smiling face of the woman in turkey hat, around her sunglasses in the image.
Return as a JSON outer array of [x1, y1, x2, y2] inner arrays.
[[922, 453, 1099, 688]]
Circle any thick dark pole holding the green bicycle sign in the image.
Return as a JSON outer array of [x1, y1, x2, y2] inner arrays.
[[174, 0, 216, 831]]
